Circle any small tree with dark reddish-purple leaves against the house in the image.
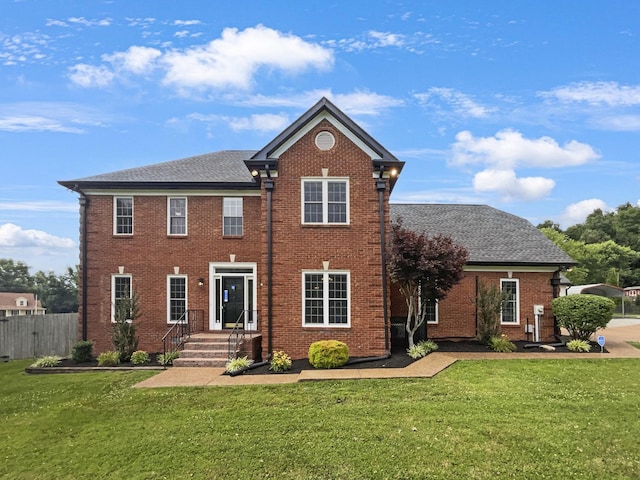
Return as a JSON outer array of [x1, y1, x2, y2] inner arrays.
[[387, 221, 468, 348]]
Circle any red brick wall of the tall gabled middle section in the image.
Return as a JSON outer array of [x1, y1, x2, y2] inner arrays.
[[261, 120, 388, 358]]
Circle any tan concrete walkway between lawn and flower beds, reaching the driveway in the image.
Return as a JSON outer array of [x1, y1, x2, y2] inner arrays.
[[135, 321, 640, 388]]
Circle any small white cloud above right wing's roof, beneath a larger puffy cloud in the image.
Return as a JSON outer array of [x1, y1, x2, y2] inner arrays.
[[473, 169, 555, 201]]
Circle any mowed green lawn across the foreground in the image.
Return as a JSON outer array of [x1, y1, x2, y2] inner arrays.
[[0, 359, 640, 480]]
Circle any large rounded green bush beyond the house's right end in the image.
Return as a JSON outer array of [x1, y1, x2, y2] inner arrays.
[[551, 294, 616, 341]]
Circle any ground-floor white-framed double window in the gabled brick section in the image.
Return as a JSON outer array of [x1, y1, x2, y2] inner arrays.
[[302, 271, 351, 327]]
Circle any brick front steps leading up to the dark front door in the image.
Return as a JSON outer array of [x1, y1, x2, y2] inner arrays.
[[173, 333, 229, 368]]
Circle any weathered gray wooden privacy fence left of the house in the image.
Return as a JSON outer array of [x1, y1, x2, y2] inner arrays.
[[0, 313, 78, 360]]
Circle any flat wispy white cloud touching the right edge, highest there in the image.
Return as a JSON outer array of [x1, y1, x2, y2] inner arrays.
[[538, 82, 640, 107]]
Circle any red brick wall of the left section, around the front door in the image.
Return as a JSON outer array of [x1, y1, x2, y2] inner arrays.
[[80, 195, 260, 353]]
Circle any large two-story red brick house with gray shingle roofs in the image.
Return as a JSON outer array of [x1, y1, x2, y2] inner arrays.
[[60, 98, 573, 358]]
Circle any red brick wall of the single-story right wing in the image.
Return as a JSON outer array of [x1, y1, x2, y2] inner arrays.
[[391, 270, 553, 340]]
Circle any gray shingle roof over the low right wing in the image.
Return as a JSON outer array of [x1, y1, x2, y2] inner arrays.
[[390, 204, 575, 266]]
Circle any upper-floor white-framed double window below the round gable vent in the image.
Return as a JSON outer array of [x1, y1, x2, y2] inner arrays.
[[302, 178, 349, 225]]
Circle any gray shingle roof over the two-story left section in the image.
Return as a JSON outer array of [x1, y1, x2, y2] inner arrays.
[[61, 150, 256, 185]]
